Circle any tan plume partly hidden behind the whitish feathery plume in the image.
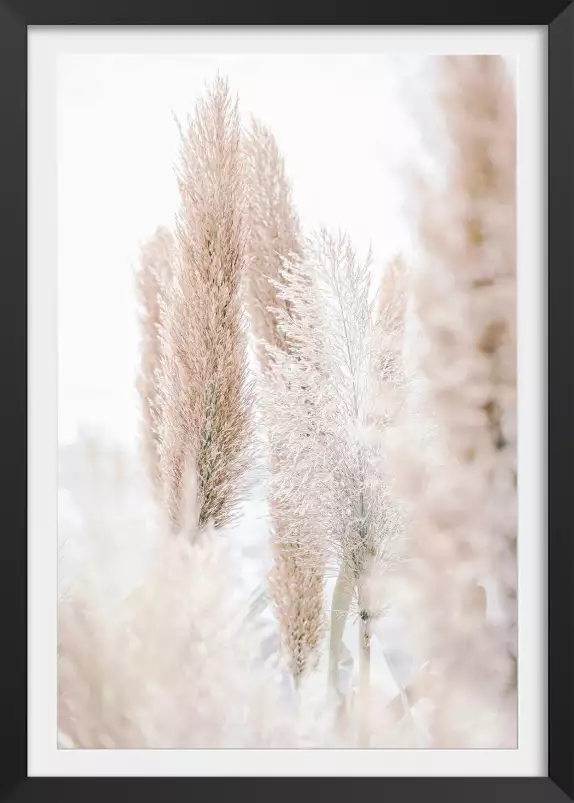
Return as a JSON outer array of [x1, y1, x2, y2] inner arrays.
[[243, 120, 325, 684]]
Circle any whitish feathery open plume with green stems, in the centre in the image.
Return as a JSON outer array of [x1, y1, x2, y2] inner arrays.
[[265, 230, 404, 724]]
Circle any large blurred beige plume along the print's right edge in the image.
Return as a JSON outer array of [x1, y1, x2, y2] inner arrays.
[[395, 56, 517, 748]]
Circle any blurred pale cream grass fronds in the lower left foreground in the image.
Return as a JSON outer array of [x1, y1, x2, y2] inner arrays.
[[58, 456, 337, 749]]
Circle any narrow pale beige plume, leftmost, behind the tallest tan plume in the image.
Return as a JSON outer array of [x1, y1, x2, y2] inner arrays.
[[137, 227, 174, 487]]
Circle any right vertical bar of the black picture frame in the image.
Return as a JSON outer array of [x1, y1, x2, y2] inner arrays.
[[548, 4, 574, 800]]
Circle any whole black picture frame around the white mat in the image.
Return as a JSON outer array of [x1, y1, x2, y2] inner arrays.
[[0, 0, 574, 803]]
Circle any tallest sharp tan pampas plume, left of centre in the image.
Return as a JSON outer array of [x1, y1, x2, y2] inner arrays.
[[158, 77, 252, 529]]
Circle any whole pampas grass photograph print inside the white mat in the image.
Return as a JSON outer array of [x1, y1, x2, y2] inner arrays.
[[57, 53, 518, 749]]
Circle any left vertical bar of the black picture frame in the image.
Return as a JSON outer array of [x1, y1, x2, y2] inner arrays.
[[0, 3, 27, 799]]
